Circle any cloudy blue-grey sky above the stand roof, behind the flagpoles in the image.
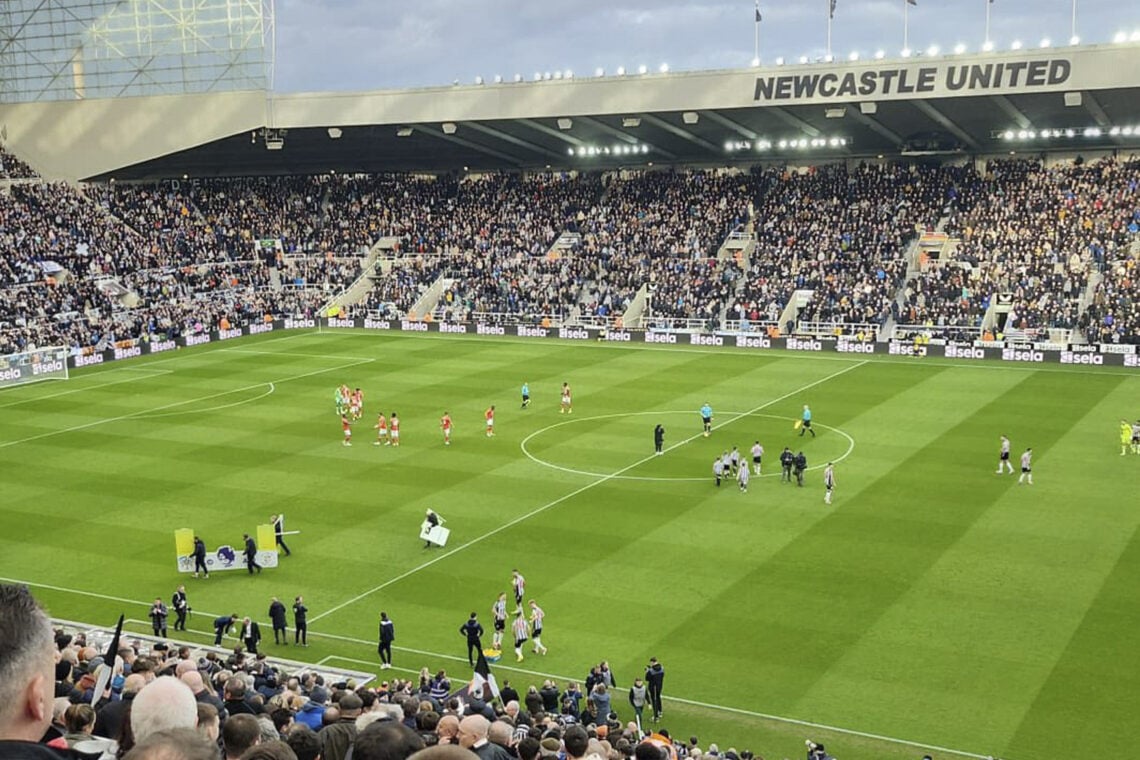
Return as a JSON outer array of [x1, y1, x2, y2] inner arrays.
[[275, 0, 1140, 92]]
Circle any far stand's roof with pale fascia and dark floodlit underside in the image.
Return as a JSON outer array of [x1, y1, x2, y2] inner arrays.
[[0, 44, 1140, 180]]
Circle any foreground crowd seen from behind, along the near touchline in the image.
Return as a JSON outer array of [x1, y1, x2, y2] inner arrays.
[[0, 585, 756, 760]]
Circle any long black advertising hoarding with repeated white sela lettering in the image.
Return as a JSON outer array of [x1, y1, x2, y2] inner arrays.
[[68, 318, 1140, 369]]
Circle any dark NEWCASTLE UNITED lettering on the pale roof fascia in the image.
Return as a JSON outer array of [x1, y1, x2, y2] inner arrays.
[[752, 58, 1073, 104]]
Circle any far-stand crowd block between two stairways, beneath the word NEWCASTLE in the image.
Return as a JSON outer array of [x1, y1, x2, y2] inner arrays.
[[733, 163, 977, 326]]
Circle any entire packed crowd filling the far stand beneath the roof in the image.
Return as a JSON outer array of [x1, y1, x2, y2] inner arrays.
[[0, 152, 1140, 352]]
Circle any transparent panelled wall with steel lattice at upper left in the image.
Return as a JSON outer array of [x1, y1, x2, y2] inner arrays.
[[0, 0, 274, 103]]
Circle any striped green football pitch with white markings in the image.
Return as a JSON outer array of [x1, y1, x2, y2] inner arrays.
[[0, 332, 1140, 760]]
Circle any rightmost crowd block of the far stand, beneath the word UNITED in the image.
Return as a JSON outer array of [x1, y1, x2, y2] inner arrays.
[[899, 158, 1140, 342]]
